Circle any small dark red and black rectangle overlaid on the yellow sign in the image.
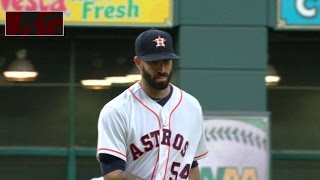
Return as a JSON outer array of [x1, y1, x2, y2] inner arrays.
[[5, 11, 64, 36]]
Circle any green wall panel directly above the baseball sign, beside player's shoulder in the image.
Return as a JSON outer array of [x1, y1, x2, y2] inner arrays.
[[178, 70, 266, 111]]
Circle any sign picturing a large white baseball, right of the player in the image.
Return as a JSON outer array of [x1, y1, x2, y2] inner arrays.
[[199, 116, 269, 180]]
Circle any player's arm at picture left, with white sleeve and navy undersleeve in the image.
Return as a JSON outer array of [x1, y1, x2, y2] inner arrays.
[[97, 106, 142, 180]]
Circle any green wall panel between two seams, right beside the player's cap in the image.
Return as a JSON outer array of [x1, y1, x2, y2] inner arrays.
[[179, 26, 267, 70]]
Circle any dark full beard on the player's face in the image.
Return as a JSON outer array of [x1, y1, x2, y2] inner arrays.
[[142, 68, 172, 90]]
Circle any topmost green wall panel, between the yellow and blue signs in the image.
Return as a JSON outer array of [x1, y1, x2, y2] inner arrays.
[[180, 0, 268, 26]]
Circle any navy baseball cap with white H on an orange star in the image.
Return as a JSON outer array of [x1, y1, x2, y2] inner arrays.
[[135, 28, 180, 61]]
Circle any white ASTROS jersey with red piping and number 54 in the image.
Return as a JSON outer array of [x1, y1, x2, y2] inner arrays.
[[97, 83, 208, 180]]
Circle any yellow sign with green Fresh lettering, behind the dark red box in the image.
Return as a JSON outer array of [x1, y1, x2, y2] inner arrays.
[[0, 0, 173, 26]]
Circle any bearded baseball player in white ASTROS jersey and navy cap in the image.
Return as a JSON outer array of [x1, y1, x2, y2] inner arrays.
[[97, 29, 208, 180]]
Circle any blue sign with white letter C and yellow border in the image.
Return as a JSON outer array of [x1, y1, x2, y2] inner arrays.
[[278, 0, 320, 29]]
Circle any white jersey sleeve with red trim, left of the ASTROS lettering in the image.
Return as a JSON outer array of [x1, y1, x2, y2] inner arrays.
[[97, 106, 126, 161]]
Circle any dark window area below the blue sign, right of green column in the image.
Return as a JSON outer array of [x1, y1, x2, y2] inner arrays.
[[267, 31, 320, 179]]
